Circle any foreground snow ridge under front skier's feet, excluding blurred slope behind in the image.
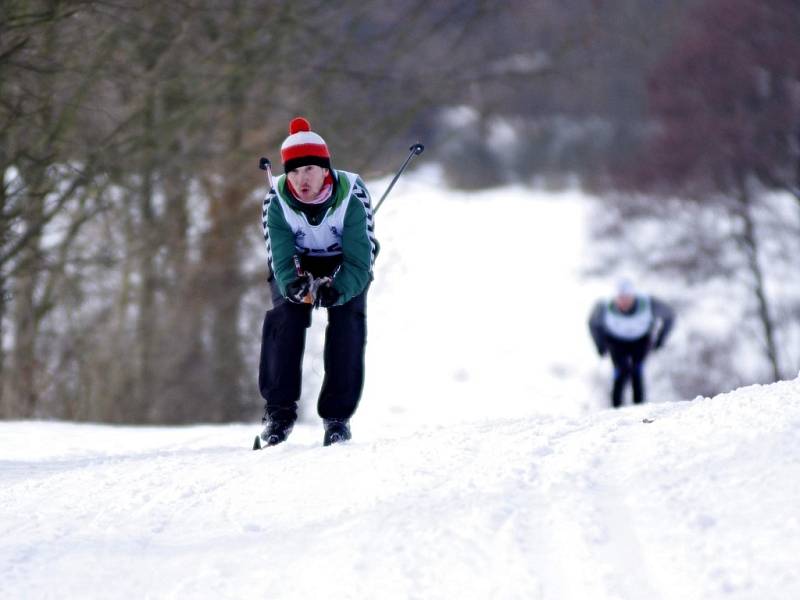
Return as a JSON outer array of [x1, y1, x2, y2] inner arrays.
[[0, 380, 800, 600]]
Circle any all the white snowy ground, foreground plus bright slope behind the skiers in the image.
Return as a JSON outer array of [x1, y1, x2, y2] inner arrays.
[[0, 171, 800, 600]]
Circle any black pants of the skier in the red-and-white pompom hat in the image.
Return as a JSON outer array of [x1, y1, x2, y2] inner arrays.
[[258, 281, 367, 422]]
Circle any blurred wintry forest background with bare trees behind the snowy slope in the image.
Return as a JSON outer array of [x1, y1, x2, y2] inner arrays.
[[0, 0, 800, 423]]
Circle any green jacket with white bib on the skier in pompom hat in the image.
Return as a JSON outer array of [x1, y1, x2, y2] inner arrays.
[[262, 170, 380, 304]]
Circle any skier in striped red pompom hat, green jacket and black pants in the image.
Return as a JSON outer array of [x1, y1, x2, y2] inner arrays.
[[254, 117, 379, 449]]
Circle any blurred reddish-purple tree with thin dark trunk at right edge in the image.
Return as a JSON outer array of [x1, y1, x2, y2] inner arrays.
[[608, 0, 800, 380]]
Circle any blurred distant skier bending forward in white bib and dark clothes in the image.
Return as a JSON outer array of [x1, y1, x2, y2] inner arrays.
[[589, 280, 675, 408]]
